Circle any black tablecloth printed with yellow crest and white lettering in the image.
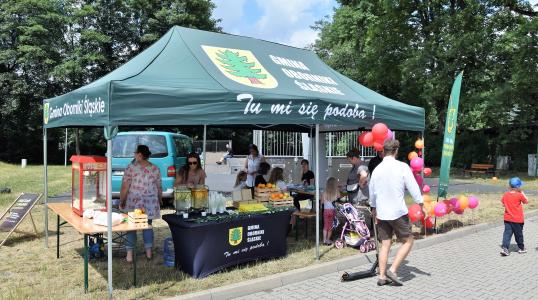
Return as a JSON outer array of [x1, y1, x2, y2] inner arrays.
[[163, 210, 292, 278]]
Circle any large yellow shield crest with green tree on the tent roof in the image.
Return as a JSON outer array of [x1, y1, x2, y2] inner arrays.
[[202, 45, 278, 89]]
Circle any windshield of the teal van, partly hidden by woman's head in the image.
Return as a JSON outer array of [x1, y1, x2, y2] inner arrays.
[[112, 134, 168, 157]]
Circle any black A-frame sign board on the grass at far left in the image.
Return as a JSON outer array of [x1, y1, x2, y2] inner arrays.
[[0, 193, 41, 246]]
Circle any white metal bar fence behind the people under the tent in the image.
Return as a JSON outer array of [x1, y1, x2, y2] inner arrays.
[[254, 130, 375, 158]]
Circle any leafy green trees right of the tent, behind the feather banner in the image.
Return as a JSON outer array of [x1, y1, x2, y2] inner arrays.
[[313, 0, 538, 167]]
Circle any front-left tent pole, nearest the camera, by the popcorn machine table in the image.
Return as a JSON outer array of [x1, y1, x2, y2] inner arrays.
[[105, 138, 112, 299]]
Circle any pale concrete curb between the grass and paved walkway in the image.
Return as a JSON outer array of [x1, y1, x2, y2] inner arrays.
[[171, 210, 538, 300]]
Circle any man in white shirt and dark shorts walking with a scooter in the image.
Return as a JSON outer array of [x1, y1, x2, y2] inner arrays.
[[369, 140, 423, 286]]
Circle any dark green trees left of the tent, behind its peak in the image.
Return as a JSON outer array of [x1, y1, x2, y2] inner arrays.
[[0, 0, 220, 163]]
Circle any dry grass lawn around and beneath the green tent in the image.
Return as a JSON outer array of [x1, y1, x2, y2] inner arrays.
[[0, 163, 538, 299]]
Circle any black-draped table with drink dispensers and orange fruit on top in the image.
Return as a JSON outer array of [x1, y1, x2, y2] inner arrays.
[[163, 185, 294, 278]]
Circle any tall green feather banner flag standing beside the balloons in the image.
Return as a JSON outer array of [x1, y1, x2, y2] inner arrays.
[[437, 72, 463, 197]]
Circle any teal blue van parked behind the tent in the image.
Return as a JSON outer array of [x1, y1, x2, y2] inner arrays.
[[112, 131, 192, 198]]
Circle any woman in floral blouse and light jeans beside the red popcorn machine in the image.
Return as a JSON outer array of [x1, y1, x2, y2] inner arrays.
[[120, 145, 162, 262]]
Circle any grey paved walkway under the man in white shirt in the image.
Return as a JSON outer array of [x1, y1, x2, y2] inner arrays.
[[233, 217, 538, 300]]
